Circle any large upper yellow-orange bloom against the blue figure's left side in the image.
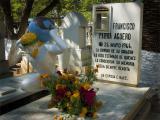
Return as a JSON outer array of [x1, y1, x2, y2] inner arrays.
[[20, 32, 37, 46]]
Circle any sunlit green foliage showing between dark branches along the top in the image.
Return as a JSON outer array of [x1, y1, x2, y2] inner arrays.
[[11, 0, 131, 25]]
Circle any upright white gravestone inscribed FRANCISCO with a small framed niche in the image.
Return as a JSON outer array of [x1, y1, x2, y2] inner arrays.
[[92, 2, 142, 86]]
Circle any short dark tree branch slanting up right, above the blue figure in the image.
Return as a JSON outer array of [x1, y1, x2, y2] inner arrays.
[[37, 0, 60, 16]]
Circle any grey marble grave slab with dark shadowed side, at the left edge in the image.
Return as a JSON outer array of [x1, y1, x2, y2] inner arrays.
[[0, 73, 49, 114]]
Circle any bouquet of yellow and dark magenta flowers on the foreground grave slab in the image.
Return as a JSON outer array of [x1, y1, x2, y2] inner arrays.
[[42, 66, 101, 118]]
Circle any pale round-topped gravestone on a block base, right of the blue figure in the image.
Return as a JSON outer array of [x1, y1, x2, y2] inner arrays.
[[59, 12, 91, 72]]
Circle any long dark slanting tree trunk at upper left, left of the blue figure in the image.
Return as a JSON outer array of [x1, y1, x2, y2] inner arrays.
[[17, 0, 34, 38]]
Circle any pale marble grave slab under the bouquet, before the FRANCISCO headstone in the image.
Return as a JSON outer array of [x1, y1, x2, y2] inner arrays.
[[0, 82, 150, 120]]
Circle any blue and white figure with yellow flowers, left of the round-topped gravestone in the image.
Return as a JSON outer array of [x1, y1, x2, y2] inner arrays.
[[17, 17, 67, 90]]
